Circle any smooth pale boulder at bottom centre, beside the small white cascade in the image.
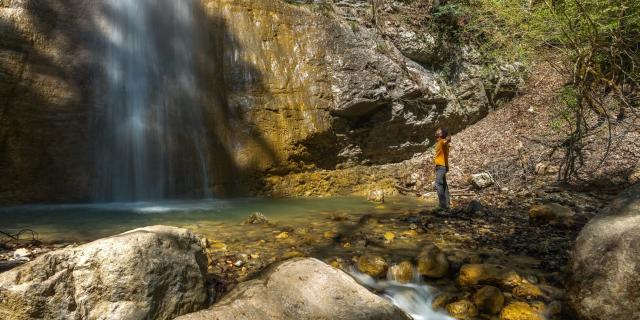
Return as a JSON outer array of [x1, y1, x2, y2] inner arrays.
[[177, 258, 410, 320]]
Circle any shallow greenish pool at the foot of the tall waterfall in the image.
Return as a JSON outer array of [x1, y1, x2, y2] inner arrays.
[[0, 197, 427, 242]]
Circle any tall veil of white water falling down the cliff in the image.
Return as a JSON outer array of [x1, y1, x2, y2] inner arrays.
[[95, 0, 210, 202]]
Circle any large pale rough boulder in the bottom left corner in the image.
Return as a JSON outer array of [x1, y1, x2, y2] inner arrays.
[[0, 226, 207, 320]]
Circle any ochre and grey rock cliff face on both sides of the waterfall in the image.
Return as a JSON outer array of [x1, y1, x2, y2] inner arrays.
[[0, 0, 520, 203]]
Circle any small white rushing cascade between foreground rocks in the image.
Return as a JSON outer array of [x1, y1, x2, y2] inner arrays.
[[349, 268, 454, 320]]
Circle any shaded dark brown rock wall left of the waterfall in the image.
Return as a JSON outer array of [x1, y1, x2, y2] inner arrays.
[[0, 1, 93, 203]]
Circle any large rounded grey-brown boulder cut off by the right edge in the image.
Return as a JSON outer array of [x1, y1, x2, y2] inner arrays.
[[569, 185, 640, 320]]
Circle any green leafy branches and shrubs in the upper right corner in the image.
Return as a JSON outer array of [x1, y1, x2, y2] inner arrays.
[[456, 0, 640, 180]]
